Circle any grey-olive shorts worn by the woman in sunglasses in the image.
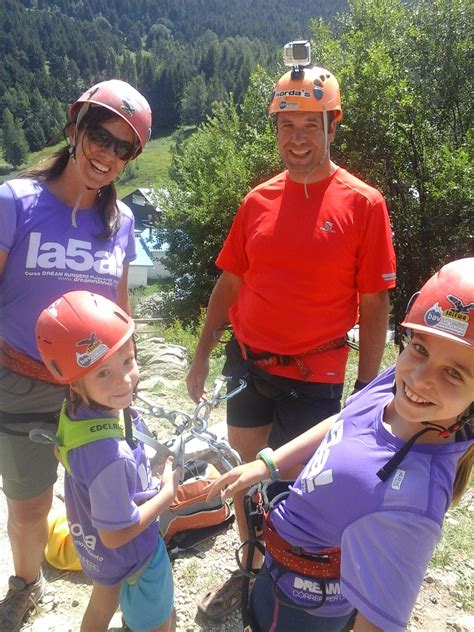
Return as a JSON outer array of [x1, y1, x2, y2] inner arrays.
[[0, 367, 64, 500]]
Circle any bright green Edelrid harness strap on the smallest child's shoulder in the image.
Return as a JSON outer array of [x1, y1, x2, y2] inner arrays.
[[56, 404, 125, 476]]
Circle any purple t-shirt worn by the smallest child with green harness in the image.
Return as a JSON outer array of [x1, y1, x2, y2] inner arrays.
[[65, 408, 160, 584]]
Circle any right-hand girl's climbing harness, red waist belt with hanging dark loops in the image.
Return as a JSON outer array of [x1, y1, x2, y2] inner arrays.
[[241, 481, 341, 631]]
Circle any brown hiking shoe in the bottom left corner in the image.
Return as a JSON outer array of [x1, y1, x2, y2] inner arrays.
[[0, 570, 45, 632]]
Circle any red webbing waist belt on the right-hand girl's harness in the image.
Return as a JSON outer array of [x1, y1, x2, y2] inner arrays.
[[263, 512, 341, 579]]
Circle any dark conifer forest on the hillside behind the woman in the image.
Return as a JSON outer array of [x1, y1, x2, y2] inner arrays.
[[0, 0, 346, 165]]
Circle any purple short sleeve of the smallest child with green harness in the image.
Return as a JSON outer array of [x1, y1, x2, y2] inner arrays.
[[89, 459, 139, 531]]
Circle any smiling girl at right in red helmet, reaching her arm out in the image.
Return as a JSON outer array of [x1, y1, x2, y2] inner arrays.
[[210, 258, 474, 632]]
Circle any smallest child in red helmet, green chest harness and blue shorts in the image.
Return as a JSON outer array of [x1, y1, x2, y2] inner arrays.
[[36, 291, 180, 632]]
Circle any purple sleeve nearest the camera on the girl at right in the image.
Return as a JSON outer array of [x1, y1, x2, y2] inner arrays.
[[341, 511, 441, 632]]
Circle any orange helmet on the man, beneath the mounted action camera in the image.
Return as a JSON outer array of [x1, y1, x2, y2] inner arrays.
[[268, 67, 342, 121]]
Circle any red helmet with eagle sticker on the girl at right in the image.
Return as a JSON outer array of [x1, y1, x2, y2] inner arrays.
[[402, 257, 474, 347]]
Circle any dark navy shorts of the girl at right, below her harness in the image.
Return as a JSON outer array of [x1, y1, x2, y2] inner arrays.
[[250, 570, 354, 632]]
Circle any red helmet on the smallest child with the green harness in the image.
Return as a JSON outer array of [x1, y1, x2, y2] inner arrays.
[[36, 290, 135, 384]]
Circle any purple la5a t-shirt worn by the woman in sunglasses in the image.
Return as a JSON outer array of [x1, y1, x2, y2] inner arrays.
[[0, 179, 136, 359]]
